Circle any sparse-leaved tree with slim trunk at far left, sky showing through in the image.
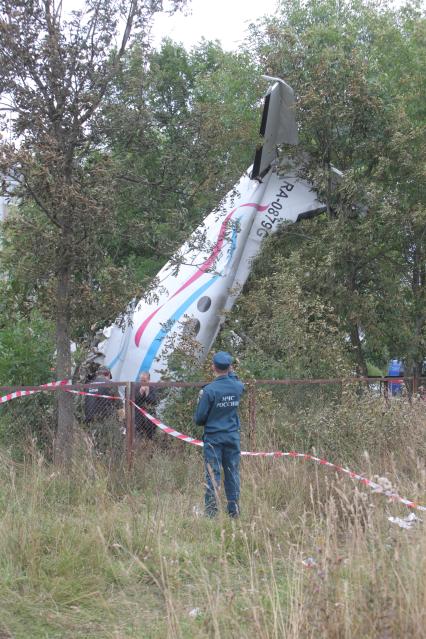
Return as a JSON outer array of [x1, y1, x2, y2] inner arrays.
[[0, 0, 186, 460]]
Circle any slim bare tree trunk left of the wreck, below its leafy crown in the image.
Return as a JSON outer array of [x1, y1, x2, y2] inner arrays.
[[55, 266, 74, 465]]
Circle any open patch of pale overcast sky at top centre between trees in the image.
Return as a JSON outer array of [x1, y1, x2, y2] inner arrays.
[[152, 0, 277, 50]]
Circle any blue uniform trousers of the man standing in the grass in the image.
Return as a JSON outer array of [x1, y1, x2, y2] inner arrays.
[[204, 431, 241, 517]]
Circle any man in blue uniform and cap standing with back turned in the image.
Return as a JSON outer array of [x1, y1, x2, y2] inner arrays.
[[194, 351, 244, 517]]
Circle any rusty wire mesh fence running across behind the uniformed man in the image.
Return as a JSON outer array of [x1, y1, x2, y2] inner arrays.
[[0, 377, 426, 466]]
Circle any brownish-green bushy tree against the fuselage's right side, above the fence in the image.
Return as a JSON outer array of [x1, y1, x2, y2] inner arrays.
[[222, 238, 350, 379]]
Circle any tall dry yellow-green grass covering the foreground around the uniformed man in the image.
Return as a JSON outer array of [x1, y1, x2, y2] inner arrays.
[[0, 397, 426, 639]]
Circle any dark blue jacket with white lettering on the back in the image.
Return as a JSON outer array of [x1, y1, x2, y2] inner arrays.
[[194, 374, 244, 434]]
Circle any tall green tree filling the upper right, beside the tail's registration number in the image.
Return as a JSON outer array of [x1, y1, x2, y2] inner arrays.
[[246, 0, 426, 373]]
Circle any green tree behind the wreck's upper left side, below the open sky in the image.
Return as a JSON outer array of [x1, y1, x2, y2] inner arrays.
[[103, 40, 259, 278]]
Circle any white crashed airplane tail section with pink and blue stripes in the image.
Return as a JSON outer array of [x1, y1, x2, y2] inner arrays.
[[96, 77, 325, 381]]
